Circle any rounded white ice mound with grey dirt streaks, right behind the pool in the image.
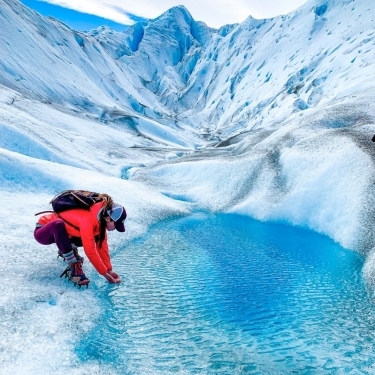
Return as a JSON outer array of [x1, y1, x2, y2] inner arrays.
[[131, 99, 375, 254]]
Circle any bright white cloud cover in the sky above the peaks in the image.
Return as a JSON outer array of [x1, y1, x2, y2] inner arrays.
[[37, 0, 307, 28]]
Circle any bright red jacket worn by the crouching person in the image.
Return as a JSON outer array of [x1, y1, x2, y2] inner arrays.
[[38, 202, 112, 275]]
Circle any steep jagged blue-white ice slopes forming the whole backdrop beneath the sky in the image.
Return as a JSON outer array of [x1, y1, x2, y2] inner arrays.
[[0, 0, 375, 139]]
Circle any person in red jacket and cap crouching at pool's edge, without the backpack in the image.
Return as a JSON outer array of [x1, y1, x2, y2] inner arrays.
[[34, 196, 126, 286]]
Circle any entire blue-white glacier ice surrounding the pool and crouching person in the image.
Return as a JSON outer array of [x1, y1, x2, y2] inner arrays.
[[0, 0, 375, 374]]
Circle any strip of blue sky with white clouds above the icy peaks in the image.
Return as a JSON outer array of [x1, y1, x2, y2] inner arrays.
[[21, 0, 307, 31]]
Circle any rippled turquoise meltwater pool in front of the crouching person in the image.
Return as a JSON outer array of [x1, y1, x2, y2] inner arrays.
[[77, 214, 375, 375]]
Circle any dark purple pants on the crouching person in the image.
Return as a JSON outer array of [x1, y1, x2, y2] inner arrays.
[[34, 219, 72, 254]]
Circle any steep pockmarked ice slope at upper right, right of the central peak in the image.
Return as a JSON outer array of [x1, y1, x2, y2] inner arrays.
[[169, 0, 375, 138]]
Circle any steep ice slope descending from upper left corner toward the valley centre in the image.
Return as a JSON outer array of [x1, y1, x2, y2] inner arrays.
[[0, 0, 206, 148]]
